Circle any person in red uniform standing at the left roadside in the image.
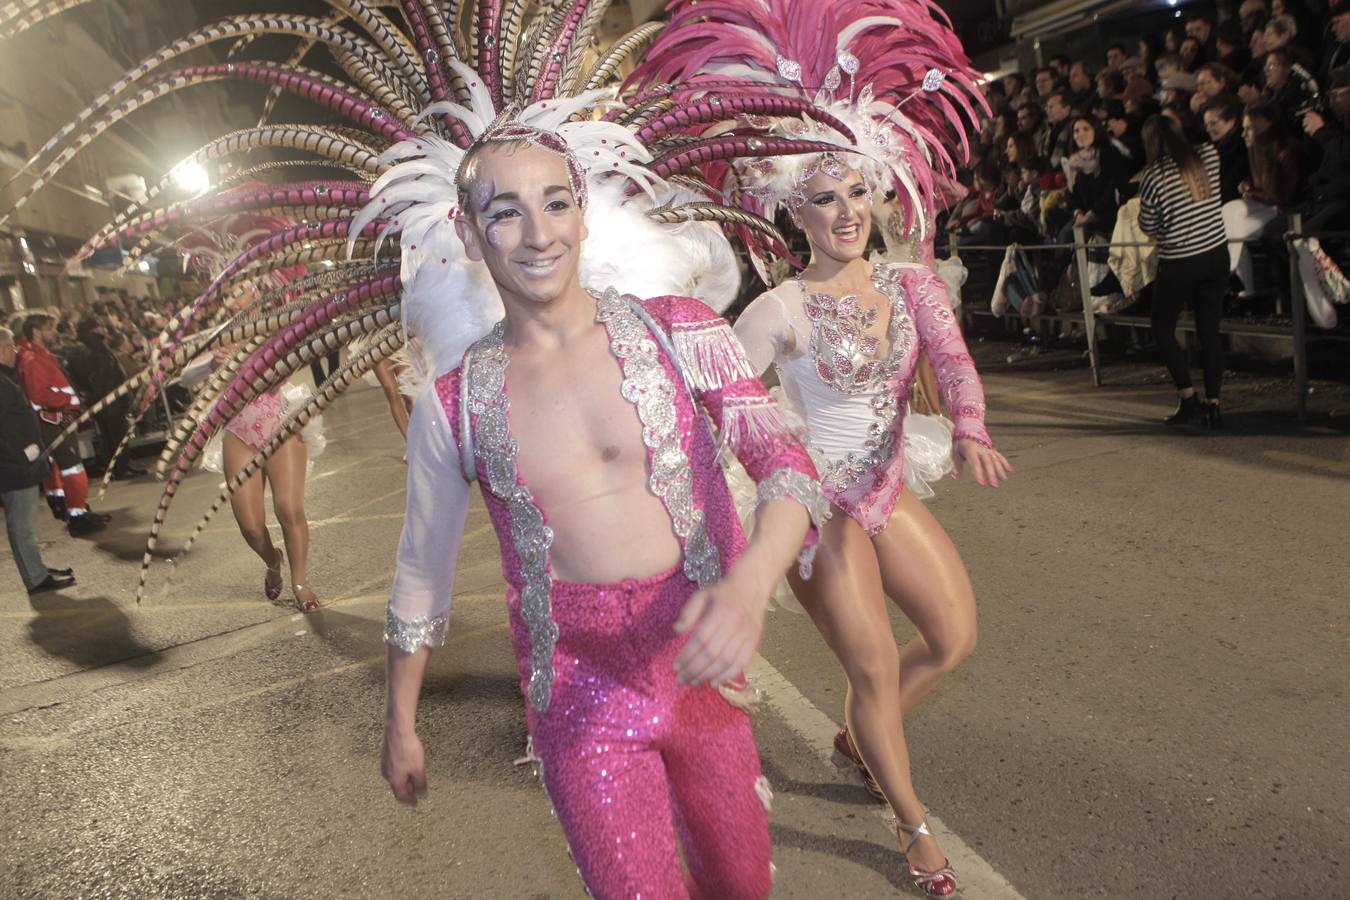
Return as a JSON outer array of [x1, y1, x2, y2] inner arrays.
[[18, 313, 109, 537]]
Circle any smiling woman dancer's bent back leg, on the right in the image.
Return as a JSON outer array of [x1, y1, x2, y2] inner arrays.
[[872, 491, 976, 715]]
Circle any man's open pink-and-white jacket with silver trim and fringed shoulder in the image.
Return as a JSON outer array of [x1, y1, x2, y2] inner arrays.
[[385, 290, 828, 712]]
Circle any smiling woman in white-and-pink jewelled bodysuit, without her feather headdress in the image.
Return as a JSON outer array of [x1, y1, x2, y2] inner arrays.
[[736, 154, 1011, 896]]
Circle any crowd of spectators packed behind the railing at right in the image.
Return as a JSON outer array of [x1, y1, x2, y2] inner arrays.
[[948, 0, 1350, 313]]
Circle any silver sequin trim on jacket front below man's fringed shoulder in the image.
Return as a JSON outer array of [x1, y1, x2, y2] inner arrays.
[[595, 287, 722, 587]]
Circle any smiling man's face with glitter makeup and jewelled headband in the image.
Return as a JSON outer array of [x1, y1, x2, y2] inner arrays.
[[455, 143, 586, 310]]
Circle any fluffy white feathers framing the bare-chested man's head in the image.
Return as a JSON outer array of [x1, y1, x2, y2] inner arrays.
[[348, 61, 740, 389]]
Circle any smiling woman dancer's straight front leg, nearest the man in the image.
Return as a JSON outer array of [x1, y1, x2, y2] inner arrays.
[[791, 509, 946, 869]]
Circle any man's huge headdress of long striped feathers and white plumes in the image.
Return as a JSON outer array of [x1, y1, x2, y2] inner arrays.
[[0, 0, 848, 601]]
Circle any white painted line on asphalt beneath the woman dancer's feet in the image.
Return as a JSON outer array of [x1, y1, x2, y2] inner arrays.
[[747, 654, 1026, 900]]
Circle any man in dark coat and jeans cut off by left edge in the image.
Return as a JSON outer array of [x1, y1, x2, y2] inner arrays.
[[0, 328, 76, 595]]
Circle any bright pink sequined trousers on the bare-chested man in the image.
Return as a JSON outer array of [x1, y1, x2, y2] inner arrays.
[[508, 568, 771, 900]]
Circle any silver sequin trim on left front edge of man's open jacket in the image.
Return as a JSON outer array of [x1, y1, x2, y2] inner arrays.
[[464, 322, 558, 712]]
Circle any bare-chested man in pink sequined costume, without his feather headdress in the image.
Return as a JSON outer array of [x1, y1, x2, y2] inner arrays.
[[383, 125, 825, 897]]
